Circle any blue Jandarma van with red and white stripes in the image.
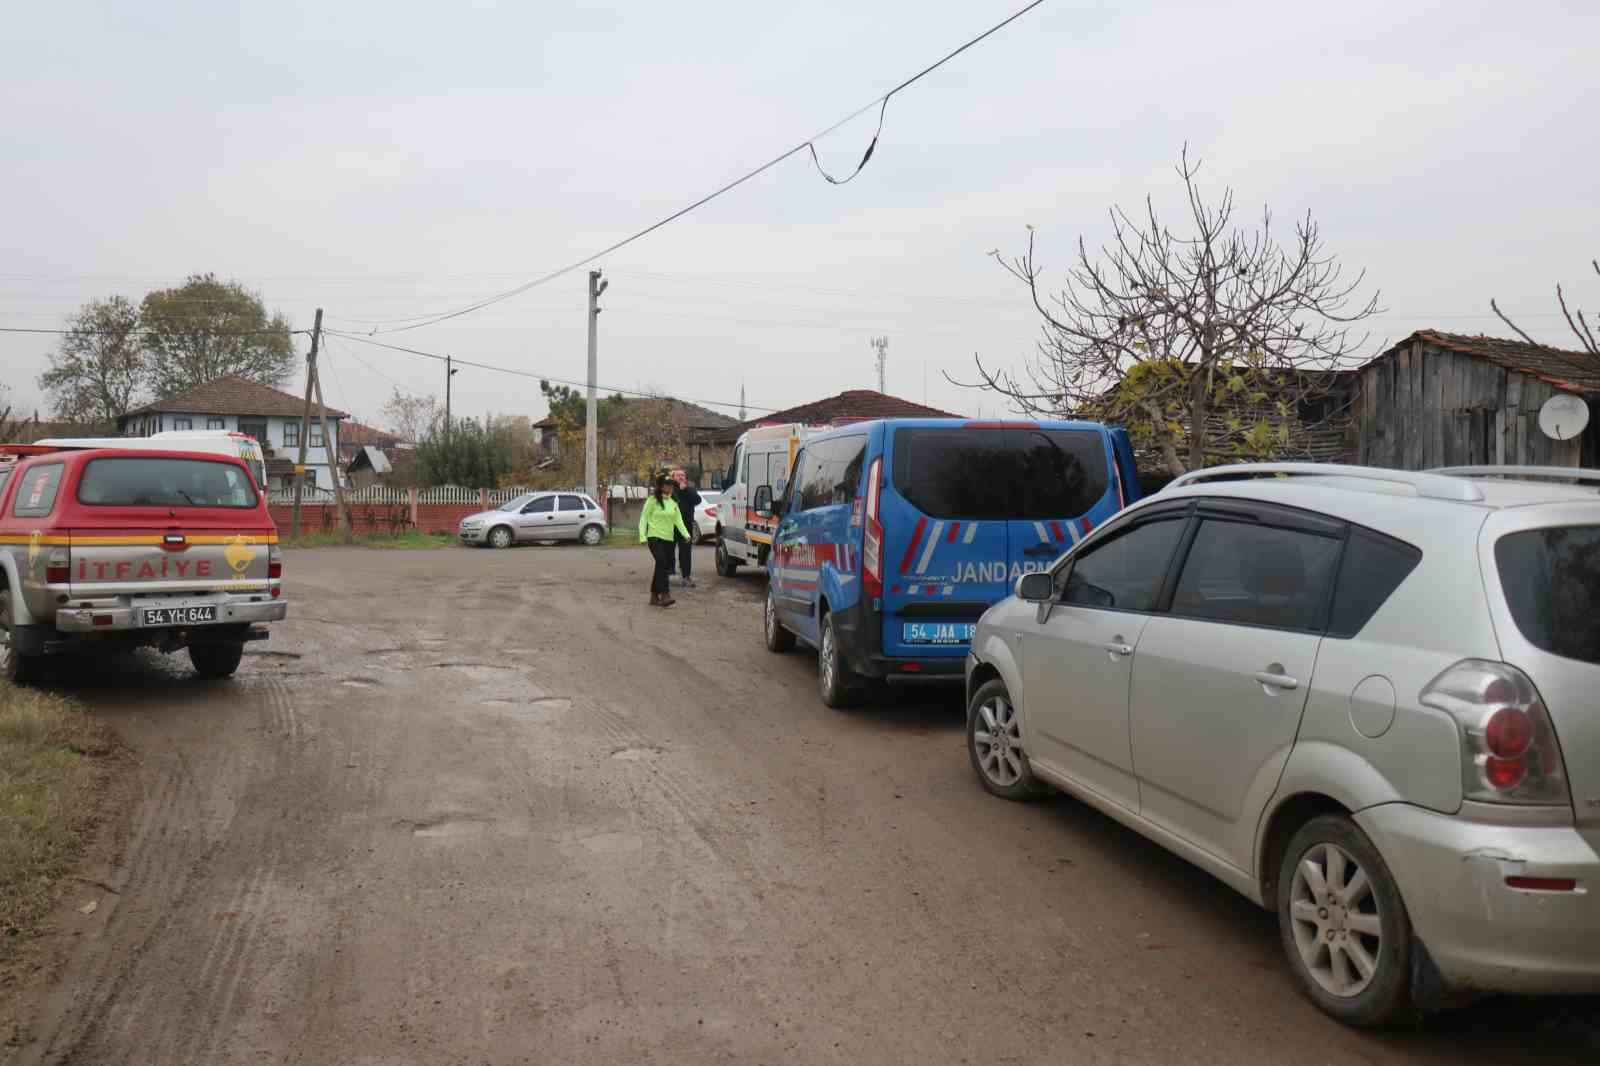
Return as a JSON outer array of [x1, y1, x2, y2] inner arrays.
[[757, 418, 1139, 707]]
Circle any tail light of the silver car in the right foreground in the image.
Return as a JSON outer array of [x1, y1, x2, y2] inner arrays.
[[1421, 659, 1573, 805]]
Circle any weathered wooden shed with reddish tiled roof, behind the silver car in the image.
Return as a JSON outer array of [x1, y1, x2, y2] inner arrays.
[[1355, 330, 1600, 471]]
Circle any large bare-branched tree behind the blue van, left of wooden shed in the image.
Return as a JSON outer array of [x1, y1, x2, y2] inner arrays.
[[952, 146, 1379, 474]]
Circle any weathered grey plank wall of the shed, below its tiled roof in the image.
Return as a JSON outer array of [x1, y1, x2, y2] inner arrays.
[[1357, 343, 1597, 471]]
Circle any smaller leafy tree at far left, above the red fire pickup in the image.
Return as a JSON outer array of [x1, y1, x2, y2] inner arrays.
[[38, 296, 150, 427]]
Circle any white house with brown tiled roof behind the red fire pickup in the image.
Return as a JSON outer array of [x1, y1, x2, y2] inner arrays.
[[117, 378, 349, 491]]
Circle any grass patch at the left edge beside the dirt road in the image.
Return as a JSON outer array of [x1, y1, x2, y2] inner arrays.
[[0, 682, 115, 966]]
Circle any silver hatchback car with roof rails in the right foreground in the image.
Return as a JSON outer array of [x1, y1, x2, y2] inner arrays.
[[966, 464, 1600, 1024]]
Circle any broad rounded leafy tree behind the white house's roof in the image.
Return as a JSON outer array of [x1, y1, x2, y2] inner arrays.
[[139, 274, 299, 395]]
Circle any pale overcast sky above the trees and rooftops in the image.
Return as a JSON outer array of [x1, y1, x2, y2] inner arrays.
[[0, 0, 1600, 419]]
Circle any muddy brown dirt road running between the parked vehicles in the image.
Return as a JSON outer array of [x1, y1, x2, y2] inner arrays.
[[9, 547, 1600, 1066]]
